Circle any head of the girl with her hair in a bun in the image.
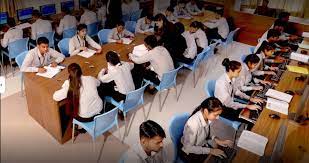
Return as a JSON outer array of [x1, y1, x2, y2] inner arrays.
[[222, 58, 241, 78]]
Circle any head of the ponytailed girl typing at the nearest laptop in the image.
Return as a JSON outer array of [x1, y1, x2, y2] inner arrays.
[[191, 97, 223, 121]]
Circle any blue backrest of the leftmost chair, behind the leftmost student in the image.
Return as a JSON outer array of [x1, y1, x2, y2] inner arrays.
[[8, 37, 29, 58]]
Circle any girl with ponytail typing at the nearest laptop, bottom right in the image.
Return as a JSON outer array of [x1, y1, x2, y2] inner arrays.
[[179, 97, 233, 163]]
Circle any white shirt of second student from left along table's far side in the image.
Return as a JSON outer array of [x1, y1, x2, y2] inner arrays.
[[69, 35, 101, 56]]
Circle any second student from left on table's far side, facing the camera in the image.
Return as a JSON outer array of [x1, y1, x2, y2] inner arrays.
[[69, 24, 102, 56]]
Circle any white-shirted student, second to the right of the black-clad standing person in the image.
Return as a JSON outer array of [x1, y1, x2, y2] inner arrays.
[[189, 21, 208, 53]]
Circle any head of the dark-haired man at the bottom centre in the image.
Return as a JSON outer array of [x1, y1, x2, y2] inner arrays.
[[139, 120, 166, 153]]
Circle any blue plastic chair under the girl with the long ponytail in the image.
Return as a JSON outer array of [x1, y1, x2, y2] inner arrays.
[[72, 106, 121, 149]]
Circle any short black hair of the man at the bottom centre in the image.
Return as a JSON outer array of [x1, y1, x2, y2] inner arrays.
[[139, 120, 166, 139]]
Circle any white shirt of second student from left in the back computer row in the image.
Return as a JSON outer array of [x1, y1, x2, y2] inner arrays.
[[31, 19, 53, 40]]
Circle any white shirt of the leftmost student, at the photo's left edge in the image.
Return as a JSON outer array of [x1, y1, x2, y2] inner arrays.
[[1, 27, 23, 48]]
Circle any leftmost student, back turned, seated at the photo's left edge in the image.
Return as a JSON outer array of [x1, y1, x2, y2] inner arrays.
[[1, 17, 23, 51]]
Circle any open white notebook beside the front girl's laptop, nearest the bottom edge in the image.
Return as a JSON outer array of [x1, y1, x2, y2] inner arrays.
[[237, 130, 268, 156]]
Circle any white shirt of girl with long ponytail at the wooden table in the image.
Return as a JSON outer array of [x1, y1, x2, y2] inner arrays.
[[53, 76, 103, 118]]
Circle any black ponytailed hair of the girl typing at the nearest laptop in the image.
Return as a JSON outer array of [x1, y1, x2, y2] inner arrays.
[[191, 97, 223, 116]]
